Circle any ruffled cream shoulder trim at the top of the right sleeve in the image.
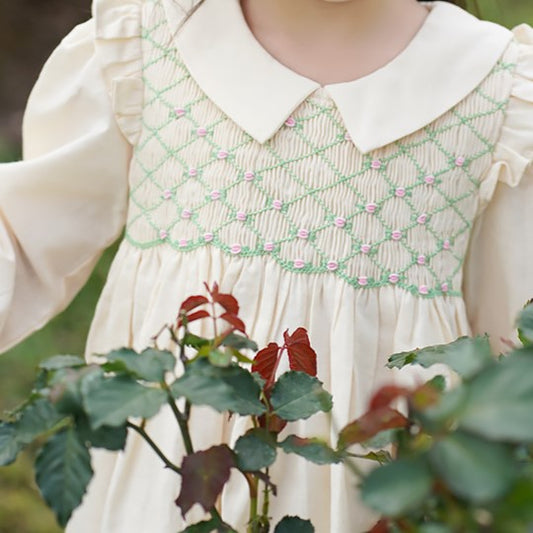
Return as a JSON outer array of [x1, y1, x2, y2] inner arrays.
[[481, 24, 533, 202]]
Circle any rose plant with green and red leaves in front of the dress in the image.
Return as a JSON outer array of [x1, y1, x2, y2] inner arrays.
[[0, 284, 533, 533]]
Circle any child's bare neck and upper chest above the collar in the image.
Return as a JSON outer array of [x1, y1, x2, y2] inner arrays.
[[241, 0, 428, 85]]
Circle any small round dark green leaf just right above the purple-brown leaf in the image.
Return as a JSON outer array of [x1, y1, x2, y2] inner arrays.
[[234, 428, 277, 472]]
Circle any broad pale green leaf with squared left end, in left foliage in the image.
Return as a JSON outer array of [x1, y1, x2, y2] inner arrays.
[[82, 376, 167, 429]]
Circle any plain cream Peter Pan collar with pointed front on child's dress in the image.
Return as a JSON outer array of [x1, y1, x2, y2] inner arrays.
[[163, 0, 512, 153]]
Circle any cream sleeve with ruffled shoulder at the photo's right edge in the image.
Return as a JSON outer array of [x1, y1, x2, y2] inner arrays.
[[463, 24, 533, 351]]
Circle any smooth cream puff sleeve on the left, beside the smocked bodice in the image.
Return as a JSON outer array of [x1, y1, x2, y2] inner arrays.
[[0, 21, 131, 352]]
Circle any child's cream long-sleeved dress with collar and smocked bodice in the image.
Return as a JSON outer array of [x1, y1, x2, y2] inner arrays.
[[0, 0, 533, 533]]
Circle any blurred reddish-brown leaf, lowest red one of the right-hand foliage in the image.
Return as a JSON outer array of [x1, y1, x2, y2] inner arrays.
[[339, 407, 409, 448]]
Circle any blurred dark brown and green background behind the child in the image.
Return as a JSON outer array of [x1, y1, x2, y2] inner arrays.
[[0, 0, 533, 533]]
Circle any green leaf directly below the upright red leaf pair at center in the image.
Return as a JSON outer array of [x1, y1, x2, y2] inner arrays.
[[270, 371, 333, 421]]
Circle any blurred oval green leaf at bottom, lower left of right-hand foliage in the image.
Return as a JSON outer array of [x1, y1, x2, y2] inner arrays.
[[361, 456, 433, 517]]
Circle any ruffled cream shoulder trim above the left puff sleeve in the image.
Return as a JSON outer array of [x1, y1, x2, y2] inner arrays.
[[92, 0, 144, 145]]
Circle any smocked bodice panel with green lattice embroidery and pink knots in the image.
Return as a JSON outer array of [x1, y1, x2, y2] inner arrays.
[[126, 2, 513, 297]]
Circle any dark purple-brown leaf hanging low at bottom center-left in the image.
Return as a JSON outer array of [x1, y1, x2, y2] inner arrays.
[[176, 444, 235, 518]]
